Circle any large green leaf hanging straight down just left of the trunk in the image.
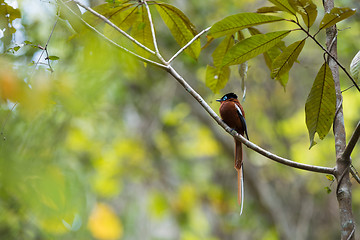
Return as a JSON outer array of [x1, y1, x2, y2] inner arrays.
[[305, 63, 336, 148]]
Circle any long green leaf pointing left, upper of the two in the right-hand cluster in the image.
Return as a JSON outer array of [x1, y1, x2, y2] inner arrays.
[[209, 13, 284, 38]]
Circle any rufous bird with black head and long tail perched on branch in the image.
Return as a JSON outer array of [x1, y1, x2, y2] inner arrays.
[[216, 93, 249, 215]]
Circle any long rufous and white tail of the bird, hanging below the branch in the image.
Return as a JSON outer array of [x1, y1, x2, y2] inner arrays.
[[234, 139, 244, 215]]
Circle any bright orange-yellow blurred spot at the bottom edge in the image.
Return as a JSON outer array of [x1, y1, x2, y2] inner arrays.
[[88, 203, 123, 240]]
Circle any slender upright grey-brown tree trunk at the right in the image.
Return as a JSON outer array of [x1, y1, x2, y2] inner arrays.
[[323, 0, 355, 239]]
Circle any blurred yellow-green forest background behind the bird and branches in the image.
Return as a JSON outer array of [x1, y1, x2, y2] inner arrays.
[[0, 0, 360, 240]]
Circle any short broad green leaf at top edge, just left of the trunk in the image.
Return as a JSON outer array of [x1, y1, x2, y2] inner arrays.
[[289, 0, 317, 27]]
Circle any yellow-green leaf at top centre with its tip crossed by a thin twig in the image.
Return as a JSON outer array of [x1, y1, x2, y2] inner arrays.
[[155, 2, 201, 59]]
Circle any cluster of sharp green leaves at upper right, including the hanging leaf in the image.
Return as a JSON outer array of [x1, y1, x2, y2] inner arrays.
[[206, 0, 355, 146]]
